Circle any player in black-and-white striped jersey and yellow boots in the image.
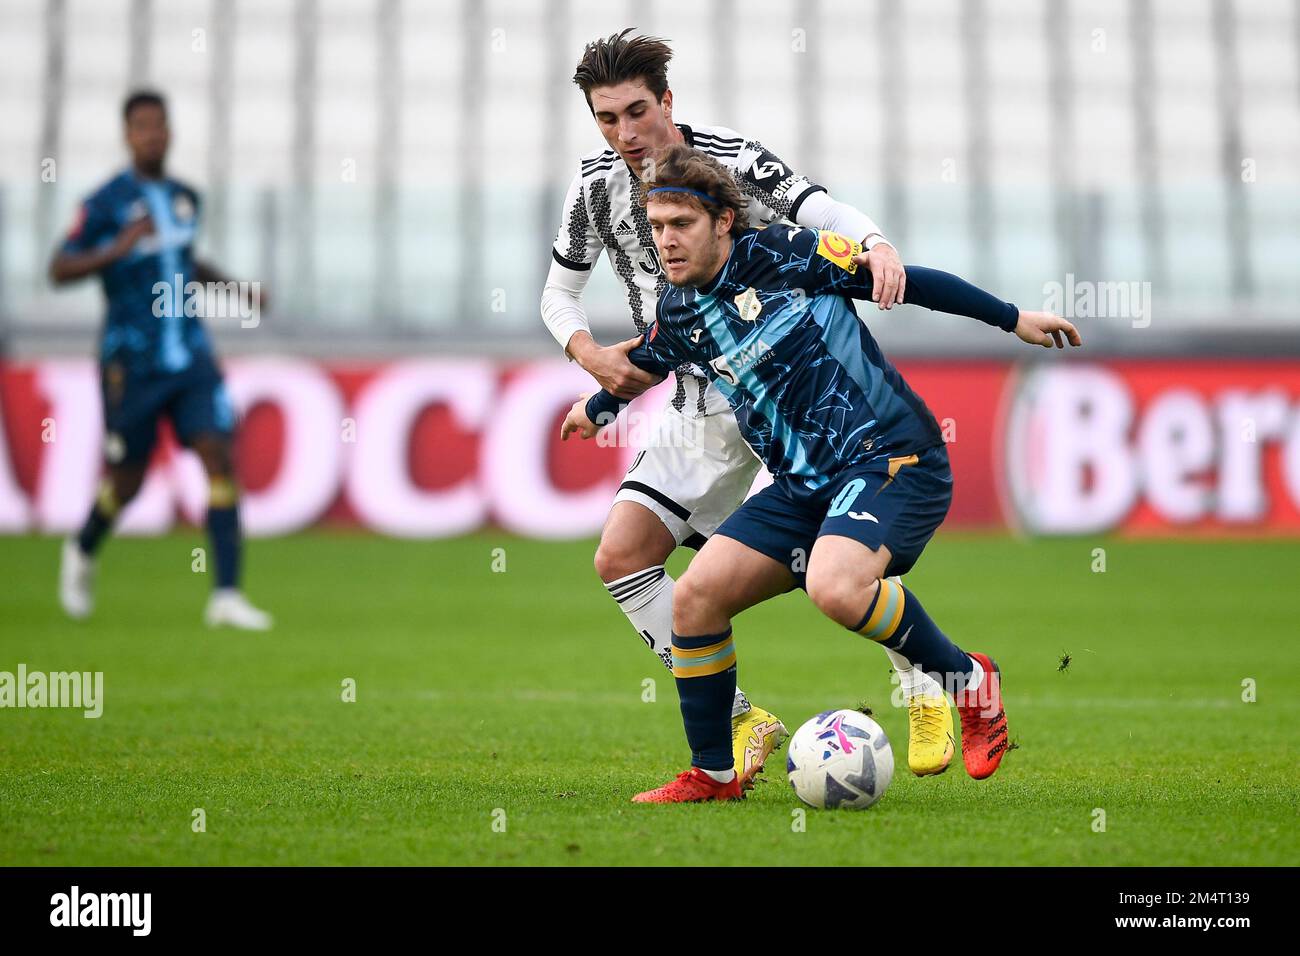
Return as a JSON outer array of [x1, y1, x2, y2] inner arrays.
[[542, 29, 953, 787]]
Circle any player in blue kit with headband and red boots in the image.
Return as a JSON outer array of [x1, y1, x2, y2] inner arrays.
[[562, 146, 1082, 803]]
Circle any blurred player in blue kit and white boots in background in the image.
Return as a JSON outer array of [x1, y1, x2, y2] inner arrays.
[[49, 91, 272, 631]]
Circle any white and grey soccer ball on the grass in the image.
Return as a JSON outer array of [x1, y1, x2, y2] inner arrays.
[[785, 710, 893, 810]]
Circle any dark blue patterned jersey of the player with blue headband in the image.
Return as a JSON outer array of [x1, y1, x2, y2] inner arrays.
[[588, 224, 1019, 492]]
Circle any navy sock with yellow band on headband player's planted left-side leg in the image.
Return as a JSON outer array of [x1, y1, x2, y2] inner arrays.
[[672, 627, 736, 770]]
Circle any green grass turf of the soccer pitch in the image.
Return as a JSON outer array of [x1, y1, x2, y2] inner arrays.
[[0, 533, 1300, 865]]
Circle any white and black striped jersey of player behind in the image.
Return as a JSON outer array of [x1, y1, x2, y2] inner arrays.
[[543, 124, 883, 415]]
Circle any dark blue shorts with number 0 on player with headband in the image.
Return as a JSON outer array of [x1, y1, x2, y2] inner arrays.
[[715, 445, 953, 588]]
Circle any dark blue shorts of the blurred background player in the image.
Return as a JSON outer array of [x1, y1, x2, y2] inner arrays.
[[100, 360, 235, 464]]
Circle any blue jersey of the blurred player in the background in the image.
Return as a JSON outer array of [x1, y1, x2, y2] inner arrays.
[[64, 170, 211, 375]]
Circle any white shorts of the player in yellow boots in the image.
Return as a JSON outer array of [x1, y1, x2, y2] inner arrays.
[[614, 405, 762, 548]]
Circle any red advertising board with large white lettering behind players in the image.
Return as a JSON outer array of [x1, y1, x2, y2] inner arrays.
[[0, 358, 1300, 537]]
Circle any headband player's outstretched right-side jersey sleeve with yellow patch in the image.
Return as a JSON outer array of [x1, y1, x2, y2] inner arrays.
[[759, 226, 1021, 332]]
